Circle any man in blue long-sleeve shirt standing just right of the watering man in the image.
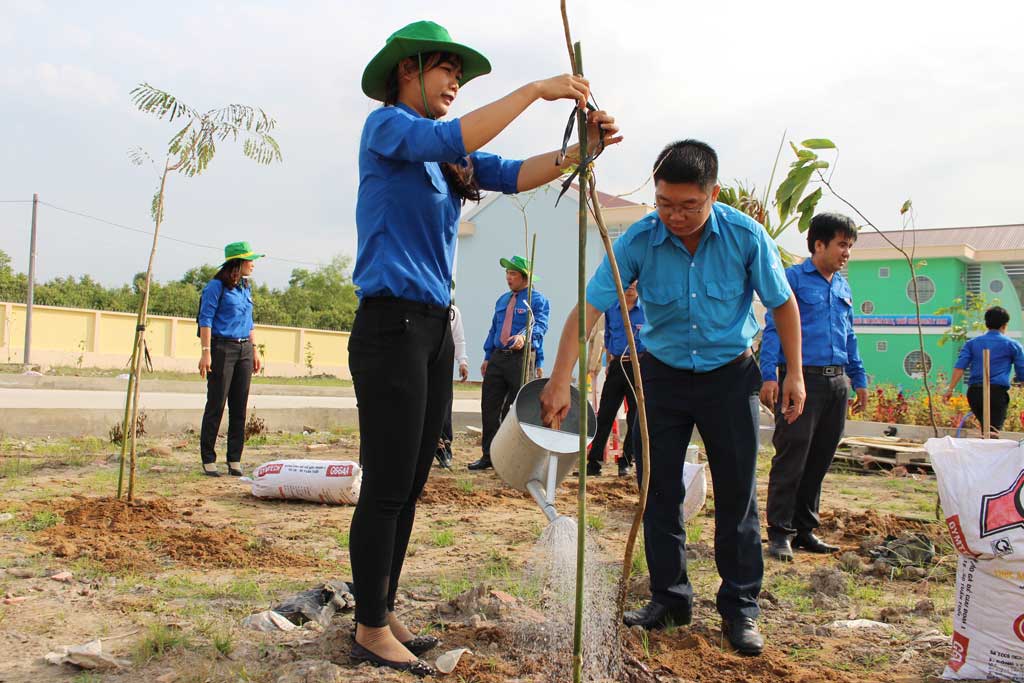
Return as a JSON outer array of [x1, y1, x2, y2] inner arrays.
[[761, 213, 867, 562]]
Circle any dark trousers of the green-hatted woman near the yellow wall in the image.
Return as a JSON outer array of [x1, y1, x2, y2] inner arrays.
[[199, 339, 253, 464]]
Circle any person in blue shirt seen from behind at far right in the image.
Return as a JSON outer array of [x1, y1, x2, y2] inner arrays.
[[945, 306, 1024, 432]]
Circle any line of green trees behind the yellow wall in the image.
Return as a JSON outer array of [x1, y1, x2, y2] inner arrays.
[[0, 250, 357, 330]]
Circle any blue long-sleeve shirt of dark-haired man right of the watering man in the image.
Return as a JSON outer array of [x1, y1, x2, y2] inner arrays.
[[761, 259, 867, 389]]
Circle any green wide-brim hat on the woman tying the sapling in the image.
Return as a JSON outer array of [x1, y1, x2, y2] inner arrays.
[[362, 22, 490, 101]]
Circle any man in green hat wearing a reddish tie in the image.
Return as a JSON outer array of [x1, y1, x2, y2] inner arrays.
[[469, 256, 551, 470]]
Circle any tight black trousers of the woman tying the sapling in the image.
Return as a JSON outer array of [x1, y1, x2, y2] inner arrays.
[[348, 297, 455, 627]]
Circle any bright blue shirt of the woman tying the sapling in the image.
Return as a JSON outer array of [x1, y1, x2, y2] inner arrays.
[[352, 104, 522, 306]]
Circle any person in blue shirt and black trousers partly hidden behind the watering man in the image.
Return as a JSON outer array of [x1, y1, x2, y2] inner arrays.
[[587, 281, 647, 476]]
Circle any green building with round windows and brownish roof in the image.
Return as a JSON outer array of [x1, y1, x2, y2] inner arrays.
[[847, 225, 1024, 389]]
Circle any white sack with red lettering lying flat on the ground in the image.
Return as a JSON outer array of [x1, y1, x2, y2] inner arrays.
[[242, 460, 362, 505]]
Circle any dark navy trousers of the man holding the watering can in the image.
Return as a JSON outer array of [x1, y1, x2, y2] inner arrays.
[[634, 351, 764, 620]]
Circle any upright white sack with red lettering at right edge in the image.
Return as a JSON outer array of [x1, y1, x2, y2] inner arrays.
[[925, 436, 1024, 682]]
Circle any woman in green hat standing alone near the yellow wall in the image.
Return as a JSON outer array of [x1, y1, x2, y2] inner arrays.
[[193, 242, 264, 476]]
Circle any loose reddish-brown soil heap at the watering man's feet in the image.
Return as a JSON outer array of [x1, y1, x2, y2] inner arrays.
[[647, 629, 856, 683]]
